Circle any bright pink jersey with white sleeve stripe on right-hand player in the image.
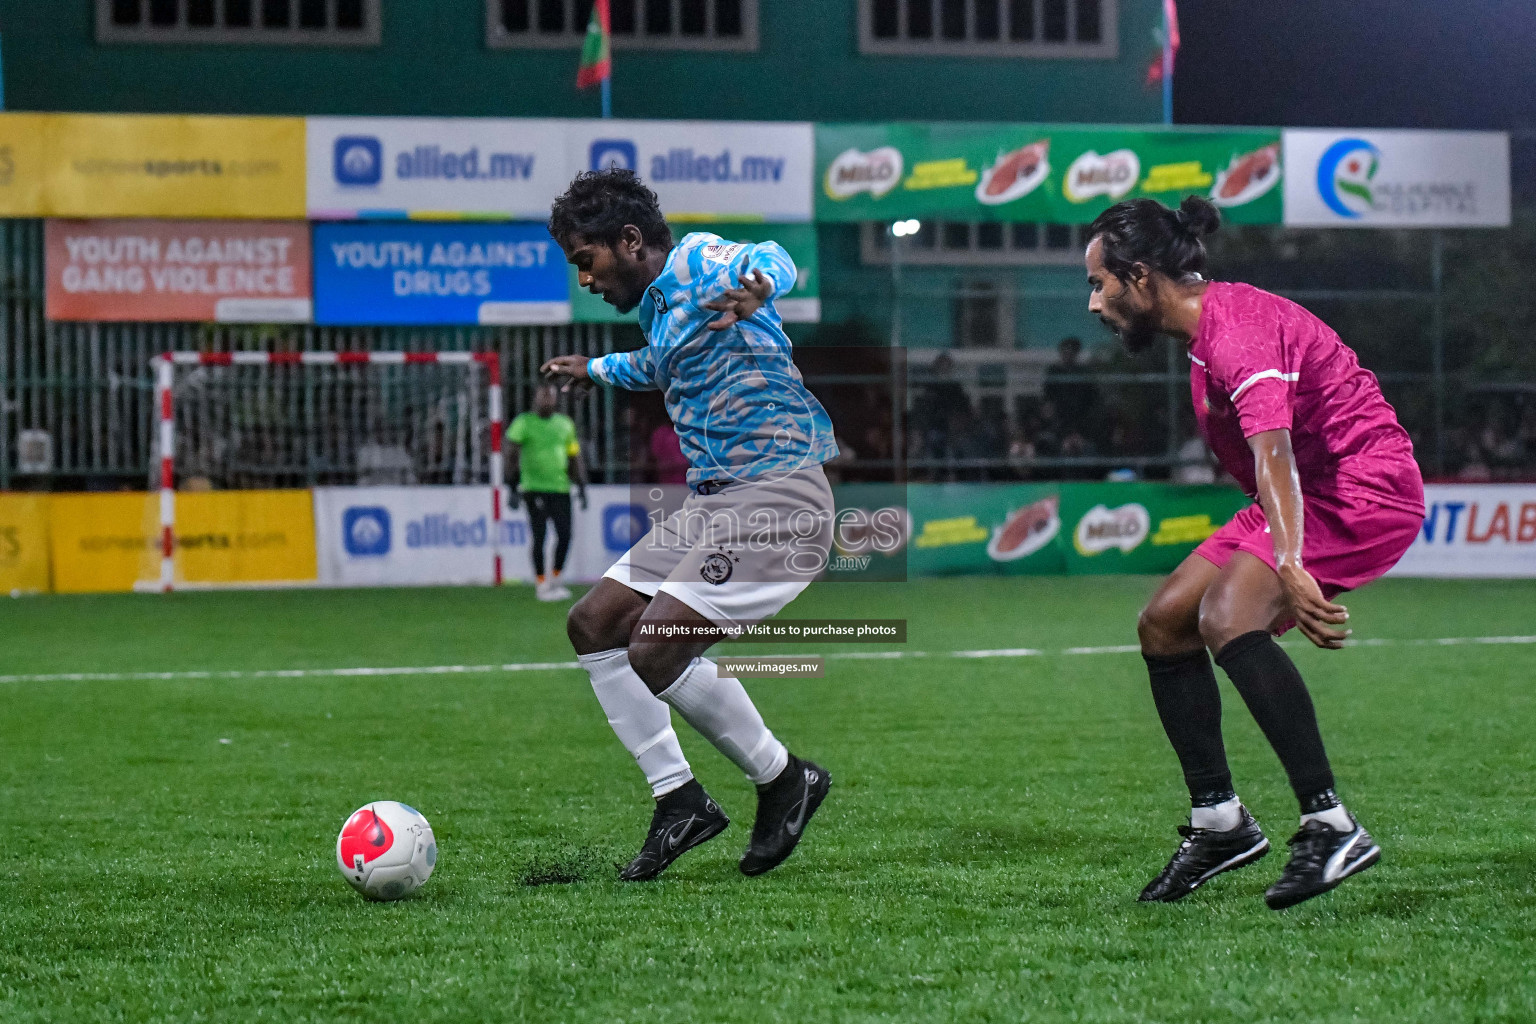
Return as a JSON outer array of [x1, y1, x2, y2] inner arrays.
[[1189, 282, 1424, 516]]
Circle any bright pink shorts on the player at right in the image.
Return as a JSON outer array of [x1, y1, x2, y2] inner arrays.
[[1195, 496, 1424, 600]]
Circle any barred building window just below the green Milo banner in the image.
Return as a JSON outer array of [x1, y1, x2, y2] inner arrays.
[[860, 220, 1087, 267]]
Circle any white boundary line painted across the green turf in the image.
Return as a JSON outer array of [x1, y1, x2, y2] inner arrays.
[[0, 636, 1536, 683]]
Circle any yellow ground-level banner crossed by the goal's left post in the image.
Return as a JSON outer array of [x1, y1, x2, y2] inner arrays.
[[51, 491, 316, 594]]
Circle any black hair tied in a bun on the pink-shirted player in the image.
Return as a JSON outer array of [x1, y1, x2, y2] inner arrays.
[[1087, 195, 1221, 281]]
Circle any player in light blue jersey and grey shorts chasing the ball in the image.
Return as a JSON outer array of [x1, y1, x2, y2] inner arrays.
[[542, 169, 837, 881]]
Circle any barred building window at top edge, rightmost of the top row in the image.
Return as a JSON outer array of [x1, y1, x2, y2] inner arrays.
[[859, 0, 1120, 58]]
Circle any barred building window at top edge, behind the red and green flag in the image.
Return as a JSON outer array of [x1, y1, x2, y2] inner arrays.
[[485, 0, 757, 51]]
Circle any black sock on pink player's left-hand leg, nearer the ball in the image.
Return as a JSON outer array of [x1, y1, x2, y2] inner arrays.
[[1141, 648, 1235, 808]]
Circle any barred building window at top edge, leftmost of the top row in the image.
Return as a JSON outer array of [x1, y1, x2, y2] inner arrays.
[[97, 0, 379, 46]]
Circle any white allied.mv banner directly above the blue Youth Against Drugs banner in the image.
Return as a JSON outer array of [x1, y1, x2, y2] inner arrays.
[[306, 117, 571, 223]]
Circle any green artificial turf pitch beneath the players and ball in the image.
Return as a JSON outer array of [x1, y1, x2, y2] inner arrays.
[[0, 577, 1536, 1024]]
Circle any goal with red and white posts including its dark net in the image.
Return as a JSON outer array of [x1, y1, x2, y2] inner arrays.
[[135, 352, 504, 593]]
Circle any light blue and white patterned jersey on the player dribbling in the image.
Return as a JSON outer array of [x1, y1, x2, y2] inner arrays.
[[587, 232, 837, 487]]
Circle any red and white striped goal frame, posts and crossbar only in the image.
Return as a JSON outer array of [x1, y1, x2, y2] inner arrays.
[[151, 352, 505, 594]]
